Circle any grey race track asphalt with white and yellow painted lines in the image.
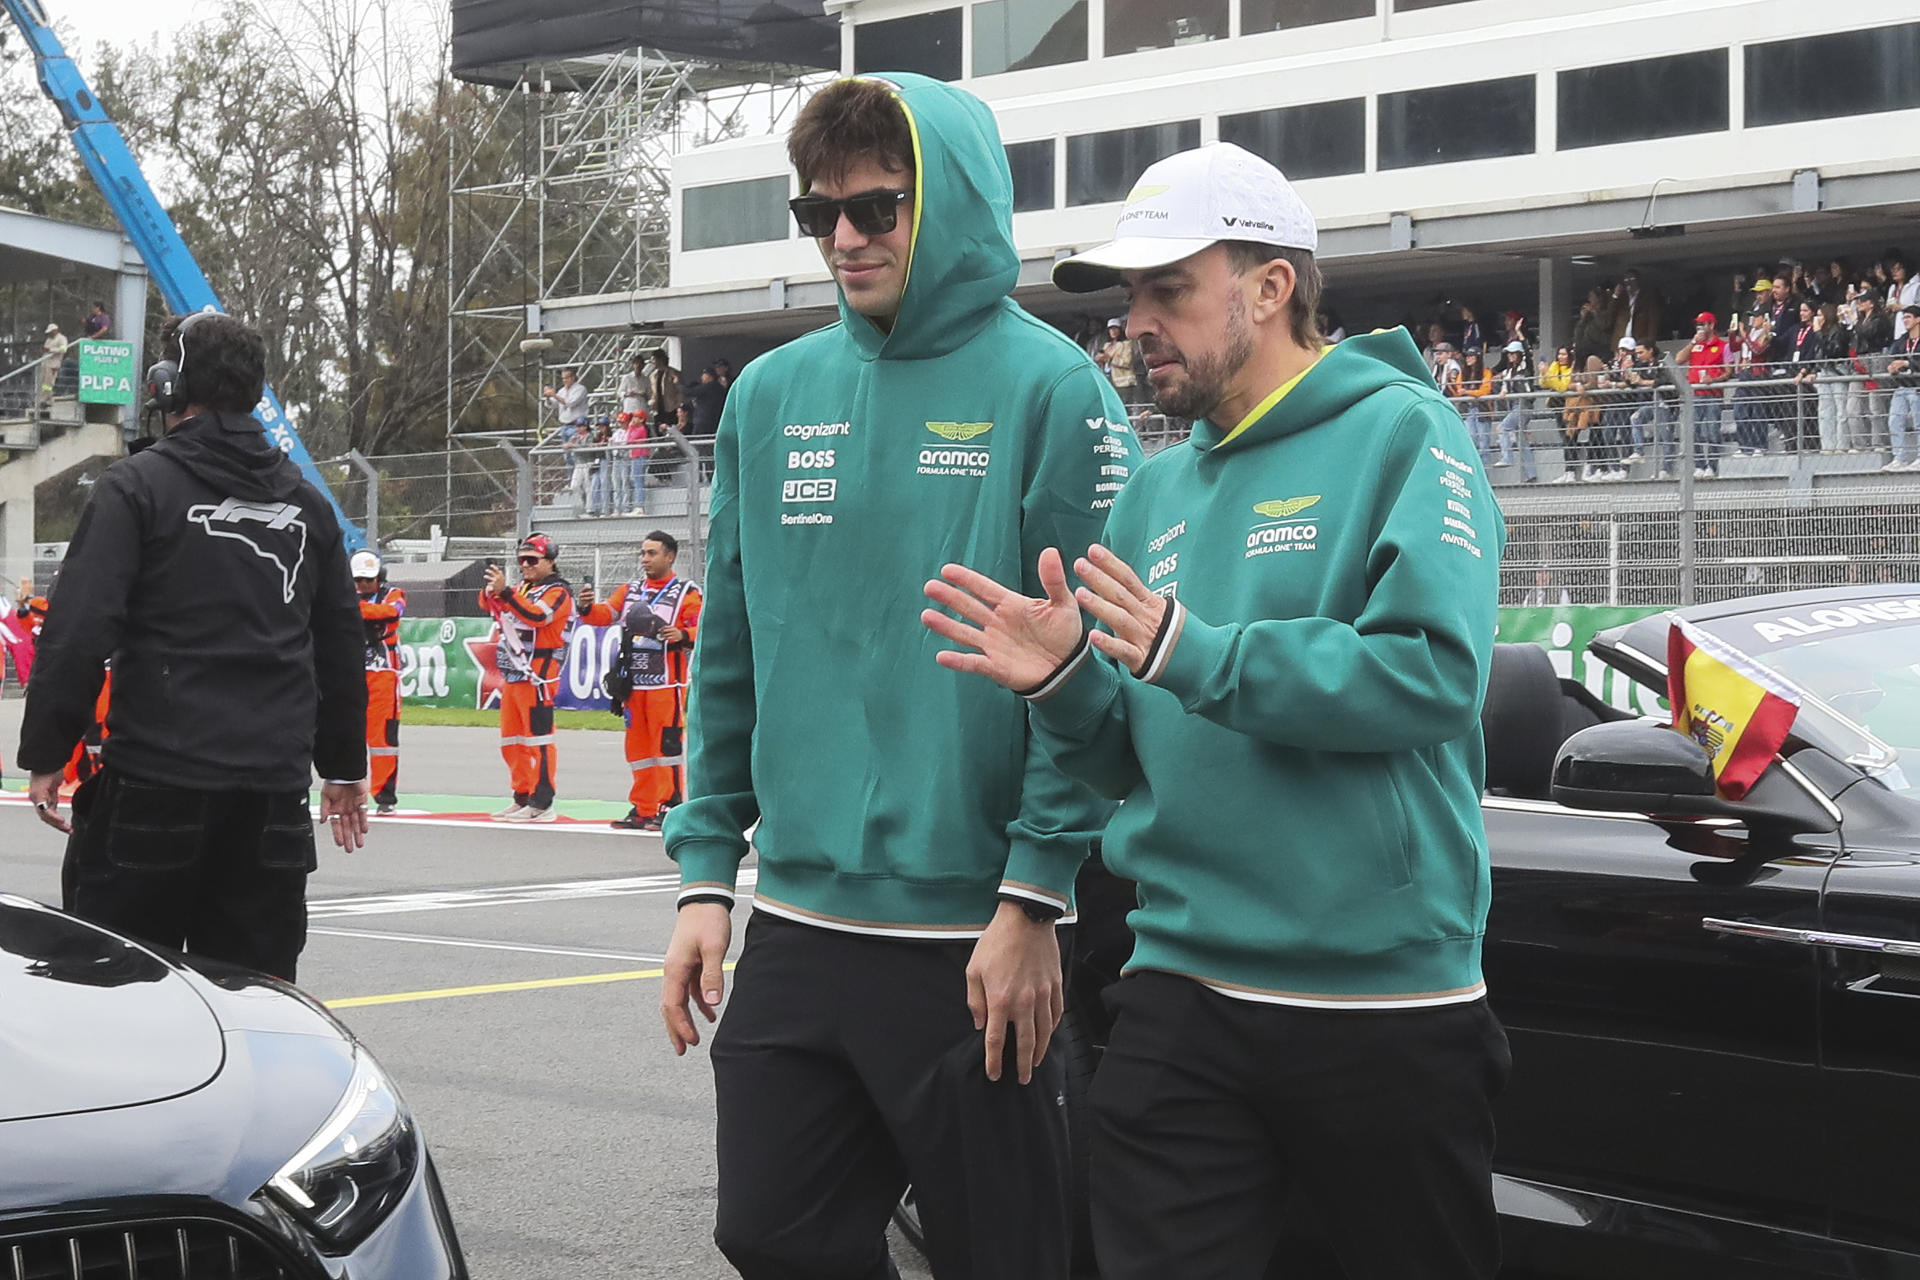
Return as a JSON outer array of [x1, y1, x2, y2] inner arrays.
[[0, 697, 927, 1280]]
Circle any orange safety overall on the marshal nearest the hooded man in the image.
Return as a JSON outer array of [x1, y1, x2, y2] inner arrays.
[[580, 574, 701, 818]]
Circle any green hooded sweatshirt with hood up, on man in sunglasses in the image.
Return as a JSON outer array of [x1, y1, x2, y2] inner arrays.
[[666, 75, 1139, 938]]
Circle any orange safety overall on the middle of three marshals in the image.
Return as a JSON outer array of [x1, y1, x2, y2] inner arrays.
[[480, 576, 574, 810]]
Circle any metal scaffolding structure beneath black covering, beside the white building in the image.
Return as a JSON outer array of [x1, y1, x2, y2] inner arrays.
[[447, 50, 828, 441]]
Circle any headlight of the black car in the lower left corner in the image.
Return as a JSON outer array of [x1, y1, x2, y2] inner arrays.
[[267, 1048, 420, 1249]]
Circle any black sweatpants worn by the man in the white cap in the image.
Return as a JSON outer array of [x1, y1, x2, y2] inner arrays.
[[1091, 973, 1511, 1280]]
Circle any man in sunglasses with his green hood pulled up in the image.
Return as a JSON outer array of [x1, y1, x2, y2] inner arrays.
[[660, 75, 1139, 1280]]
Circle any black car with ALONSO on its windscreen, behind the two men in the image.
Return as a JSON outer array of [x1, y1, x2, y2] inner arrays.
[[899, 585, 1920, 1280]]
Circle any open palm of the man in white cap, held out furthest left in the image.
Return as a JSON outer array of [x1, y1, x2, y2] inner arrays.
[[920, 547, 1085, 689]]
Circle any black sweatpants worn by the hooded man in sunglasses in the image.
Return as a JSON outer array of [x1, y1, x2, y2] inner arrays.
[[712, 912, 1069, 1280]]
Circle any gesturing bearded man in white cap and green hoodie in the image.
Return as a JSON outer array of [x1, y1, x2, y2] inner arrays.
[[924, 144, 1507, 1280]]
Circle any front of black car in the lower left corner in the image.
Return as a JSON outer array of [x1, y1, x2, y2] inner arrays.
[[0, 894, 467, 1280]]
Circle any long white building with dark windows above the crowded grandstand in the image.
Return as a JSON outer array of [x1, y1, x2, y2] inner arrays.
[[543, 0, 1920, 367]]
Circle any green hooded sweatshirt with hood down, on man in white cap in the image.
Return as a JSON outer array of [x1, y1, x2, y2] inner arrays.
[[1033, 328, 1505, 1009]]
